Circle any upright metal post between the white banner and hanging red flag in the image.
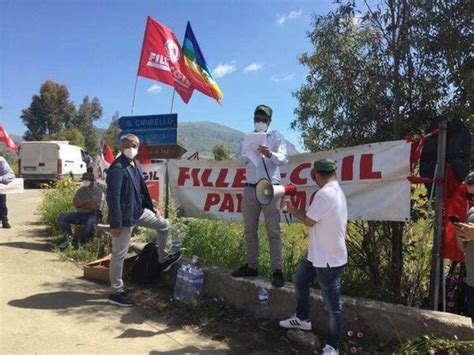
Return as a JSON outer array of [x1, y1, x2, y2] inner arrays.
[[430, 119, 447, 310]]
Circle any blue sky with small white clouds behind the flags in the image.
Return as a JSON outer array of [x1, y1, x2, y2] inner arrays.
[[0, 0, 336, 151]]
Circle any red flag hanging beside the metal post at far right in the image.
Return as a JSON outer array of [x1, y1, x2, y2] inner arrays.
[[441, 163, 468, 261]]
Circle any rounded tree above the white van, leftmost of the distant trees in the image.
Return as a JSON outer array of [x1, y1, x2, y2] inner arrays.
[[21, 80, 76, 140]]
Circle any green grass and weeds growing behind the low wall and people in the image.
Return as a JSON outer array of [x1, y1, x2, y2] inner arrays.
[[39, 180, 436, 305]]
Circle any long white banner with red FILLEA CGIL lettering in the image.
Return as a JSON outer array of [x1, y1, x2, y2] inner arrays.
[[168, 141, 411, 221]]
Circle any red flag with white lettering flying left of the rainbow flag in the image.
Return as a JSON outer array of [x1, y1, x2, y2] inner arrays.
[[138, 16, 194, 103]]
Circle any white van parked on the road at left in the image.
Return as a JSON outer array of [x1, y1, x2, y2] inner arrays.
[[18, 141, 87, 182]]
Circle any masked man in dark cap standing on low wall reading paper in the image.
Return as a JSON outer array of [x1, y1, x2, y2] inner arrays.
[[232, 105, 288, 287]]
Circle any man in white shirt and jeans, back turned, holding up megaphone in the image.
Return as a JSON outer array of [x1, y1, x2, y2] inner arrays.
[[280, 159, 347, 354]]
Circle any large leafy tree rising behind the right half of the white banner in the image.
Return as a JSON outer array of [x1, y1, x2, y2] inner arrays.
[[291, 0, 472, 301]]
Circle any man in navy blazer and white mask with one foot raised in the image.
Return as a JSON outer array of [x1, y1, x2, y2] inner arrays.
[[106, 134, 181, 307]]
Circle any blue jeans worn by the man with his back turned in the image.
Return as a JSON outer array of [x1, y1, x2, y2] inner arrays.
[[293, 256, 344, 349]]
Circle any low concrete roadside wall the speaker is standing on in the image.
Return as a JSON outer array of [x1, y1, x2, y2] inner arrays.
[[127, 249, 474, 341]]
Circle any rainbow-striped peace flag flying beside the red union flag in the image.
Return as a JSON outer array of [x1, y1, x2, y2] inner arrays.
[[183, 21, 224, 102]]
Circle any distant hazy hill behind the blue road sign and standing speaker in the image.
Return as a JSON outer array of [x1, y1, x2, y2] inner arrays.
[[178, 121, 298, 158]]
